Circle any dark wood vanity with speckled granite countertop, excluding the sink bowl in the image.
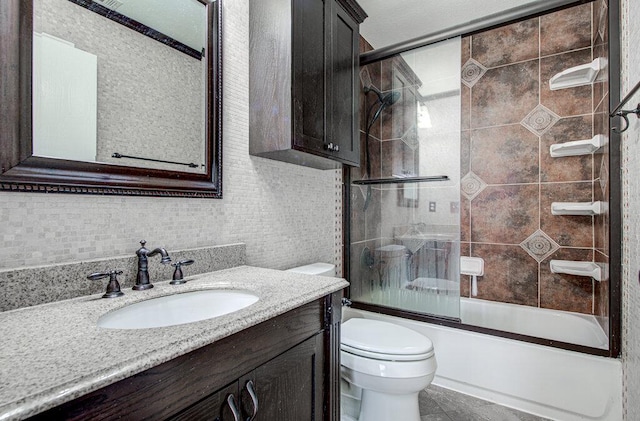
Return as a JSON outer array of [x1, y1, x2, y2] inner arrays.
[[0, 266, 347, 420]]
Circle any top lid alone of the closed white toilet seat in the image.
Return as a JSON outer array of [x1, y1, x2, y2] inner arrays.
[[340, 318, 433, 355]]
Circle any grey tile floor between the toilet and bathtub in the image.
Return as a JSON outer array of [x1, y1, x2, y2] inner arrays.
[[420, 385, 547, 421]]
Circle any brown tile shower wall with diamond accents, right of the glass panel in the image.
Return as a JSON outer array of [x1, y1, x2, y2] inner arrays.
[[460, 0, 608, 316]]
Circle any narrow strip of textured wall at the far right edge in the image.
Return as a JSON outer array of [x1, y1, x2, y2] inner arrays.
[[621, 0, 640, 421]]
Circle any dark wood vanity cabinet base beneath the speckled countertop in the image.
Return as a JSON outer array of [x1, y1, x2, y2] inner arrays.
[[32, 292, 342, 421]]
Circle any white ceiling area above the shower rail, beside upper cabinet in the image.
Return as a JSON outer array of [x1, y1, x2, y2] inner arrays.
[[358, 0, 545, 48]]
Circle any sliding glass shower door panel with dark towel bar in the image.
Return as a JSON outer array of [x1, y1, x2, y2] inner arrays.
[[349, 38, 460, 319]]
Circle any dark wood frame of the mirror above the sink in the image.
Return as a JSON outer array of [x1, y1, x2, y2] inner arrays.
[[0, 0, 222, 198]]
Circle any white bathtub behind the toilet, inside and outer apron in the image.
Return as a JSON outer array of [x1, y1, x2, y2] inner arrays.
[[344, 299, 622, 421]]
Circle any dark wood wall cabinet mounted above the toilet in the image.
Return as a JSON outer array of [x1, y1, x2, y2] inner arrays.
[[249, 0, 366, 169]]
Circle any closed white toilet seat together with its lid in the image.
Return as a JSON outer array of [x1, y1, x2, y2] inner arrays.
[[340, 318, 434, 361]]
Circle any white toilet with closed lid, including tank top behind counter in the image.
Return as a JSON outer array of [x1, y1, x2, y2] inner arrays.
[[288, 263, 437, 421]]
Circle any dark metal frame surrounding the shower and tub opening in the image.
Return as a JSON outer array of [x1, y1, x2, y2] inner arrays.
[[342, 0, 622, 358]]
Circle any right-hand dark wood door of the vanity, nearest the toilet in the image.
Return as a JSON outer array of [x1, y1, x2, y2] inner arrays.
[[240, 334, 324, 421]]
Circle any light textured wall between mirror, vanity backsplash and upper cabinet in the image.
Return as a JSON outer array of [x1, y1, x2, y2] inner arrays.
[[0, 0, 341, 269]]
